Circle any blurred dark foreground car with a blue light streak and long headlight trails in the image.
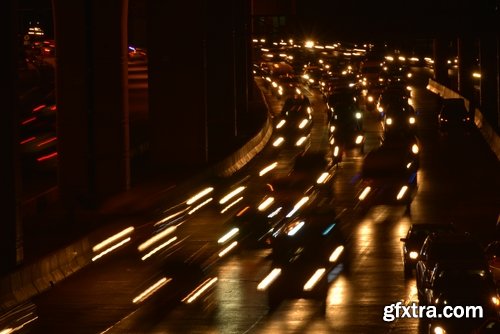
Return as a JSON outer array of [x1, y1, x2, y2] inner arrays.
[[257, 212, 350, 314]]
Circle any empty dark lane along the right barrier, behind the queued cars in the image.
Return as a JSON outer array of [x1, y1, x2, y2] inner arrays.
[[412, 83, 500, 243]]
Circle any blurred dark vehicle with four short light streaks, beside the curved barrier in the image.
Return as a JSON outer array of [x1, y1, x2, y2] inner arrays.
[[271, 98, 312, 154]]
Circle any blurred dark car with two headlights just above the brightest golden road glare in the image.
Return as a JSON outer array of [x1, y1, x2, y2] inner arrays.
[[358, 132, 419, 213]]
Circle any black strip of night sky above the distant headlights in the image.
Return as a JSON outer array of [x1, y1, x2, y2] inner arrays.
[[295, 0, 499, 39]]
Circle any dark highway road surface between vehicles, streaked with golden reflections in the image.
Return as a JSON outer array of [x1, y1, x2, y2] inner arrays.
[[17, 54, 500, 333]]
